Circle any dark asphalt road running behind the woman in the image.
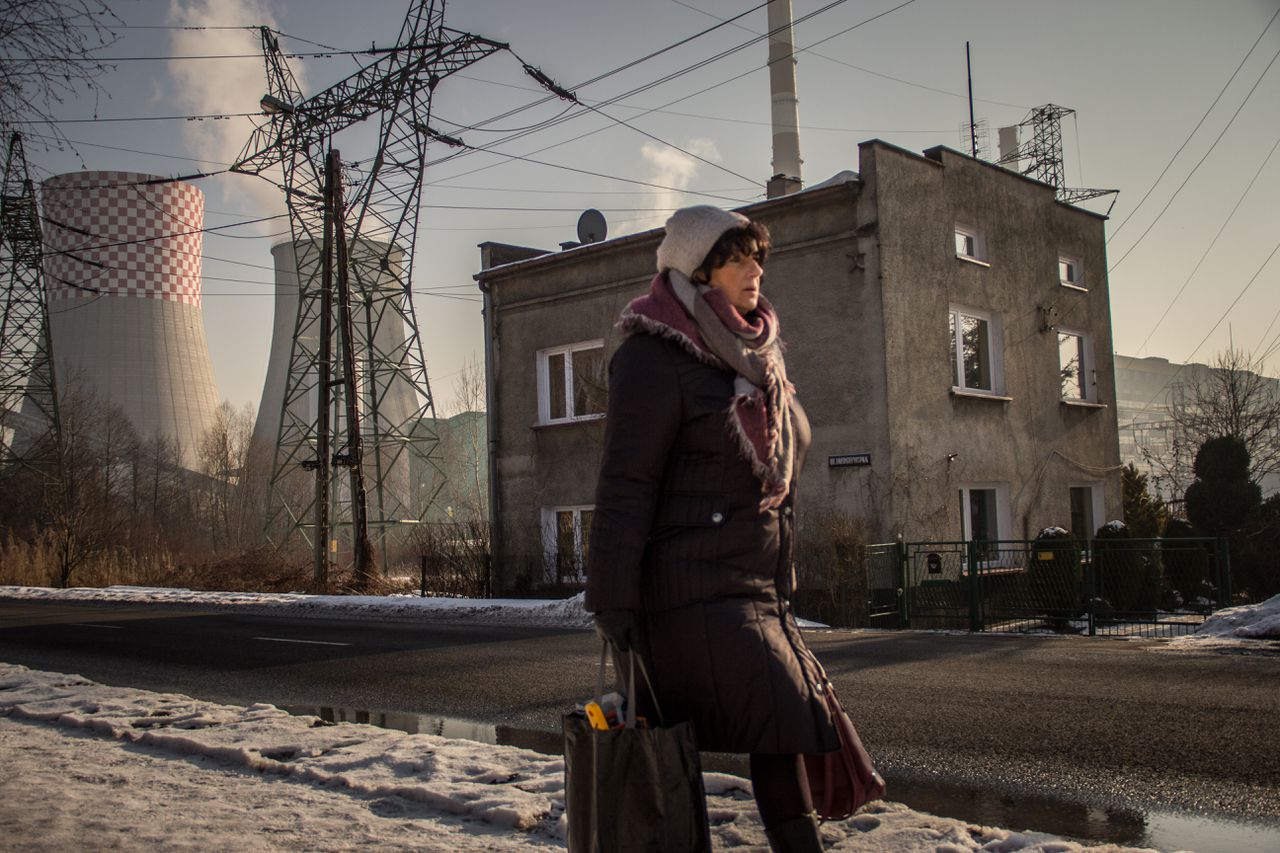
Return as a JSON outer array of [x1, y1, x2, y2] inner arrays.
[[0, 602, 1280, 843]]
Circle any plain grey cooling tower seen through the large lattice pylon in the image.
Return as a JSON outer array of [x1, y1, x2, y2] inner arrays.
[[253, 240, 421, 517]]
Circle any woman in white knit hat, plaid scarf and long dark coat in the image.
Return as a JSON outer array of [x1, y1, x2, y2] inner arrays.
[[586, 206, 840, 853]]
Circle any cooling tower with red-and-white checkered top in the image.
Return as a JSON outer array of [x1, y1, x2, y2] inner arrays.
[[41, 172, 218, 469]]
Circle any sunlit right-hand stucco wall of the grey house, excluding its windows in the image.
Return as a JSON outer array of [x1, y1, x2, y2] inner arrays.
[[861, 143, 1120, 539]]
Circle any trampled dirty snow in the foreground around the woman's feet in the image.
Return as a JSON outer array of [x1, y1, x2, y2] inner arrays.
[[0, 663, 1177, 853]]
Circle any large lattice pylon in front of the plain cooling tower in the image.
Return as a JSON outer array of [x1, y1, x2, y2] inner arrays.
[[233, 0, 507, 581]]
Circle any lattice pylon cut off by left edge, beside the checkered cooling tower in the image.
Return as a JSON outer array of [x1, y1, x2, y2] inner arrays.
[[0, 133, 61, 482]]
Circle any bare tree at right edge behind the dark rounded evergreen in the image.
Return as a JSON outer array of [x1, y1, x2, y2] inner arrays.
[[1143, 347, 1280, 496]]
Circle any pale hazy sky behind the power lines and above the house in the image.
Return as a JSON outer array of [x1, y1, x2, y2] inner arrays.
[[17, 0, 1280, 409]]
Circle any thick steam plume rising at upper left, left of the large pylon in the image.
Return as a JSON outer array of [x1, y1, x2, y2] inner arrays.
[[169, 0, 294, 227]]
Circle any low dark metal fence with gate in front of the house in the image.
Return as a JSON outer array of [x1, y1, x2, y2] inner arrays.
[[801, 539, 1231, 637]]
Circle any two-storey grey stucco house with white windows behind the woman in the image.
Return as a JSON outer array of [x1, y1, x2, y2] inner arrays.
[[476, 140, 1120, 590]]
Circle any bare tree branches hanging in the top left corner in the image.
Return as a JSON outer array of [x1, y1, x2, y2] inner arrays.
[[0, 0, 122, 136]]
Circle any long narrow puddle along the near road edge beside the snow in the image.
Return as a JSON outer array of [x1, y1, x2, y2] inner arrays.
[[284, 706, 1280, 853]]
